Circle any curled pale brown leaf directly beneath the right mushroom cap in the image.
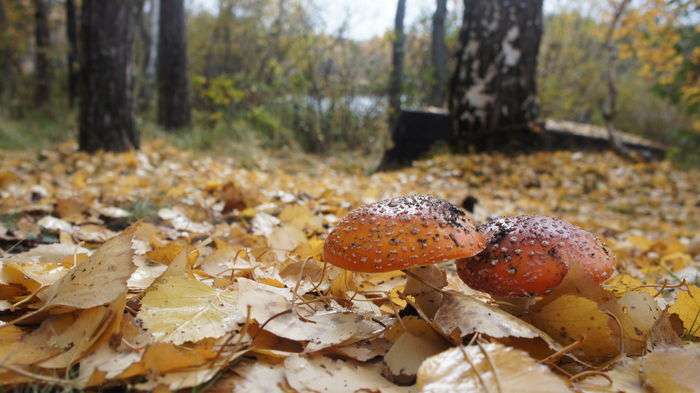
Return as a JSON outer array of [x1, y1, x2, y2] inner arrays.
[[433, 291, 560, 350]]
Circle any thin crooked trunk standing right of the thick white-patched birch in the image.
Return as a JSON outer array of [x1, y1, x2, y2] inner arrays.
[[602, 0, 631, 158]]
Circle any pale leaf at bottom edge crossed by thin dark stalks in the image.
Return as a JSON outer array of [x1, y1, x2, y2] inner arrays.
[[417, 343, 570, 393]]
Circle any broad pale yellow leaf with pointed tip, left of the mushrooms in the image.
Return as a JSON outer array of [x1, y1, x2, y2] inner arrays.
[[137, 252, 246, 344]]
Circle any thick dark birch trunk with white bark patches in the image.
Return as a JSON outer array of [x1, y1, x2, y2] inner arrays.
[[449, 0, 542, 149]]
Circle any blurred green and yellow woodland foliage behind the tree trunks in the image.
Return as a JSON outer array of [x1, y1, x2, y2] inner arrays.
[[0, 0, 700, 165]]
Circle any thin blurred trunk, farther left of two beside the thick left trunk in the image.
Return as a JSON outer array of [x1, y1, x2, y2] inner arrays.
[[34, 0, 51, 106]]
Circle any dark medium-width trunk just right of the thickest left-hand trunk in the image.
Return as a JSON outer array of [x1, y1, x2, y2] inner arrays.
[[158, 0, 190, 130]]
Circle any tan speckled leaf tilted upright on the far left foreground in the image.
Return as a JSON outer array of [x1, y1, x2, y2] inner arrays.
[[39, 231, 136, 308]]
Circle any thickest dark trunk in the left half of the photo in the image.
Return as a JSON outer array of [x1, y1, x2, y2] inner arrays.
[[79, 0, 139, 152]]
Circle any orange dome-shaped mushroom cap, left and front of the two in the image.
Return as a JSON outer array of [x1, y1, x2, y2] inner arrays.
[[323, 195, 485, 272]]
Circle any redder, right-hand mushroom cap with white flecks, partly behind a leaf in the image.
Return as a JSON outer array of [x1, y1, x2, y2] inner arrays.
[[457, 216, 615, 297]]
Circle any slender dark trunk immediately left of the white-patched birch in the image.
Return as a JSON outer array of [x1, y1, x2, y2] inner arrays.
[[430, 0, 448, 107]]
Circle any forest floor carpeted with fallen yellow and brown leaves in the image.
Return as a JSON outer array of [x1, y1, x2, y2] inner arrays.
[[0, 141, 700, 392]]
